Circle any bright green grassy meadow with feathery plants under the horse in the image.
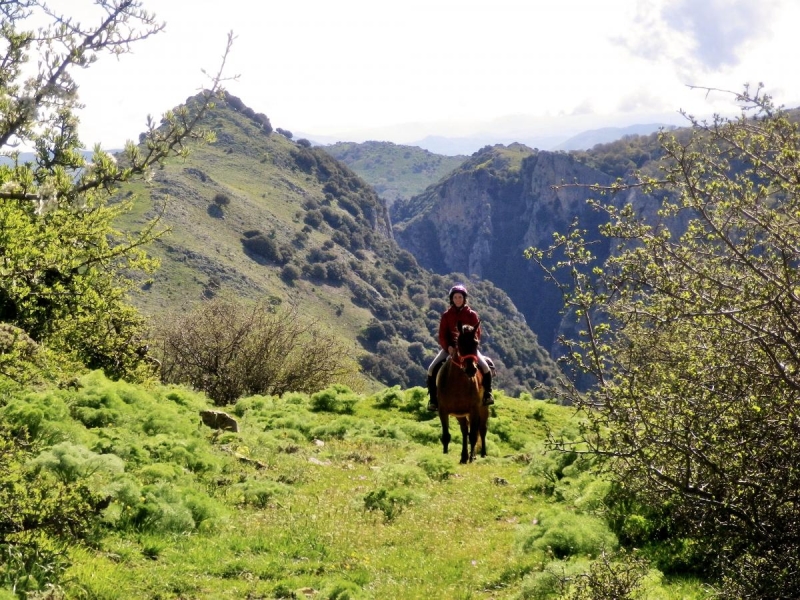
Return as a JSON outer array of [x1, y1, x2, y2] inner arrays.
[[0, 372, 708, 600]]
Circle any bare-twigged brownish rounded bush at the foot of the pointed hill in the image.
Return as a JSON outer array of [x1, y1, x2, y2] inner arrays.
[[152, 297, 354, 405]]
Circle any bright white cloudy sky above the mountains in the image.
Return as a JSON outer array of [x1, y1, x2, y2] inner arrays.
[[65, 0, 800, 151]]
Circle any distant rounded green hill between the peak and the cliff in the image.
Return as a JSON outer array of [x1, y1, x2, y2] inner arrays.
[[325, 141, 467, 207]]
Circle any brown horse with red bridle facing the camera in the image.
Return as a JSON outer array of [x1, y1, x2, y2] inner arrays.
[[436, 325, 489, 464]]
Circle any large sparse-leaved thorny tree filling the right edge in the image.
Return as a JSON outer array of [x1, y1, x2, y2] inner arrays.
[[529, 88, 800, 598]]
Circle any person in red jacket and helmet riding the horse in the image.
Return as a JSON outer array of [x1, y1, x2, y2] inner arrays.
[[428, 283, 494, 411]]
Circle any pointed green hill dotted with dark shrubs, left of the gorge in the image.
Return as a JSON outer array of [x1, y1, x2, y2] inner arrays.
[[119, 96, 558, 395]]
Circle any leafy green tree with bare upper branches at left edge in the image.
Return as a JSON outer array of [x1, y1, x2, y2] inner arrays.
[[0, 0, 232, 376]]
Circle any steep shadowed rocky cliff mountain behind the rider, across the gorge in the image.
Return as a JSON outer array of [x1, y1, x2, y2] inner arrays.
[[391, 144, 655, 355]]
